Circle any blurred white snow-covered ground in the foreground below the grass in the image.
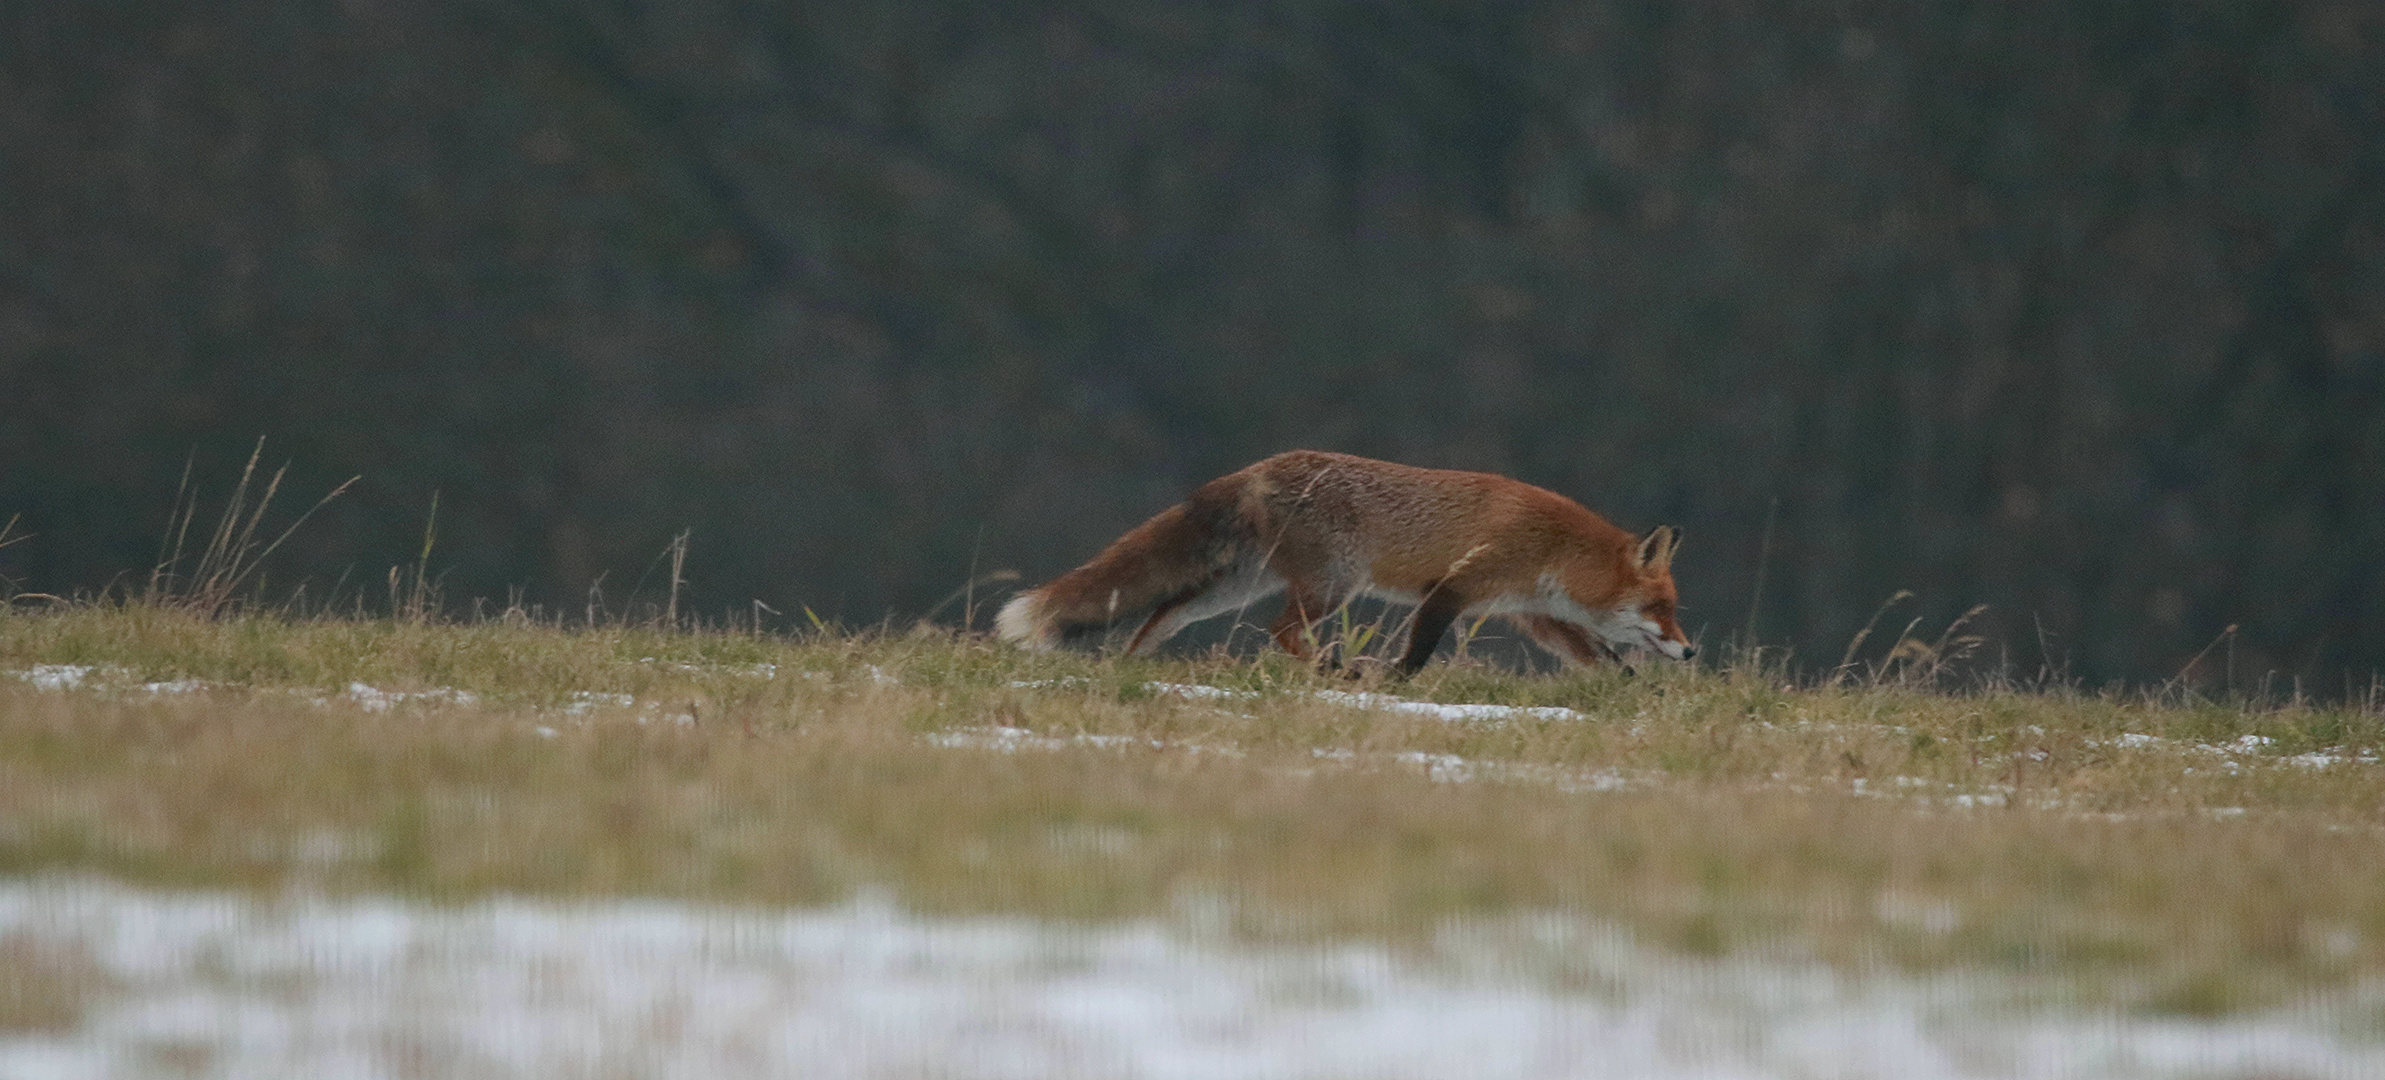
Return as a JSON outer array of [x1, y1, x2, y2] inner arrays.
[[0, 877, 2385, 1080]]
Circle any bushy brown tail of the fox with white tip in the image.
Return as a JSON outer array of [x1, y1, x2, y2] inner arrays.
[[995, 498, 1250, 648]]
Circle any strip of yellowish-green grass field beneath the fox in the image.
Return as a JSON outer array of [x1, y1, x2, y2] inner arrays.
[[0, 601, 2385, 1020]]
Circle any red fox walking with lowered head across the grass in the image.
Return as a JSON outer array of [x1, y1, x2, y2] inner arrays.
[[995, 451, 1696, 675]]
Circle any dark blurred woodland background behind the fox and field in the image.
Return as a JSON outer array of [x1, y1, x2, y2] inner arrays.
[[0, 0, 2385, 691]]
